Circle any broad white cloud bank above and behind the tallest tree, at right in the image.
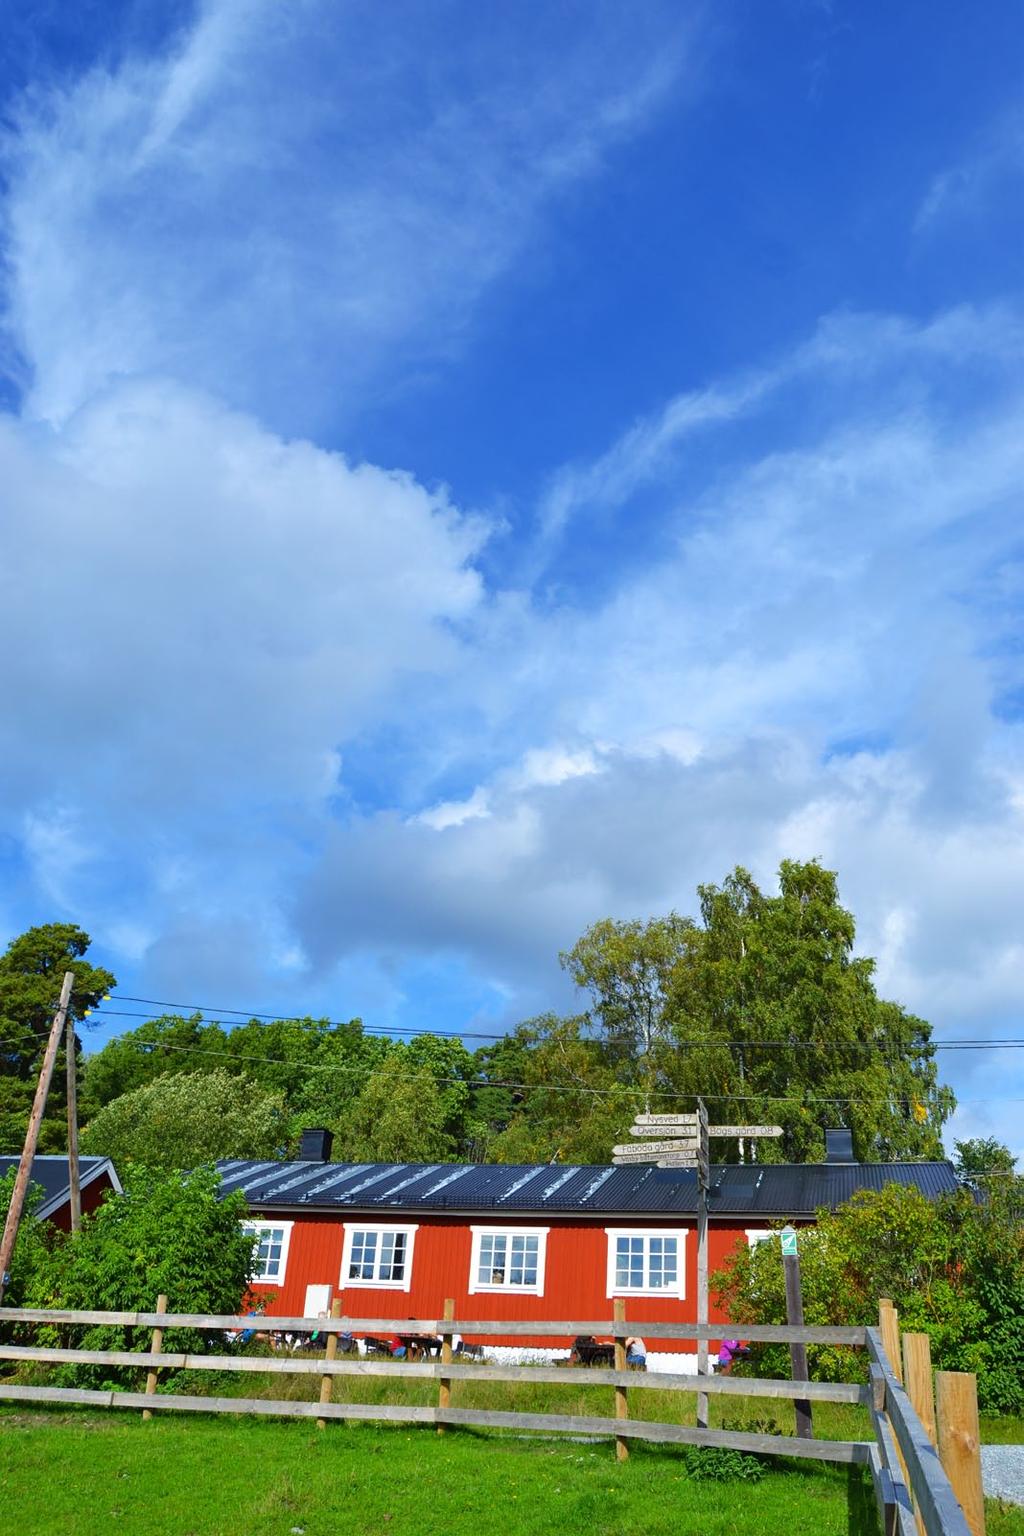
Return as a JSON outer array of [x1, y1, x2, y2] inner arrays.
[[287, 310, 1024, 1142]]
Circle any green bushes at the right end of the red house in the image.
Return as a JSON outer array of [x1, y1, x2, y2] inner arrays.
[[712, 1180, 1024, 1413]]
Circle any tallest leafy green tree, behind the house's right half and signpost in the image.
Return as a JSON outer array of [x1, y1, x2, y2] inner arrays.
[[563, 860, 955, 1161]]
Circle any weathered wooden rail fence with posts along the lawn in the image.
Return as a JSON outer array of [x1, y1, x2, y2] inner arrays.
[[0, 1296, 984, 1536]]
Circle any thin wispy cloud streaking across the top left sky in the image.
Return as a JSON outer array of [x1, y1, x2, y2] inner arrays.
[[5, 0, 691, 430]]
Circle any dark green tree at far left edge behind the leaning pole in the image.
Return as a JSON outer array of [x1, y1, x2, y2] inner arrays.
[[0, 923, 115, 1152]]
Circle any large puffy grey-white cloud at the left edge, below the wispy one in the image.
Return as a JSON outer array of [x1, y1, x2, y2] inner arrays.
[[0, 384, 485, 926]]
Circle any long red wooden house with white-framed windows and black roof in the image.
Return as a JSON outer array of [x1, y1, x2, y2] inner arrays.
[[220, 1130, 956, 1369]]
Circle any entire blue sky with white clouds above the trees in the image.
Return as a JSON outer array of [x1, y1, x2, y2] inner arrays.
[[0, 0, 1024, 1150]]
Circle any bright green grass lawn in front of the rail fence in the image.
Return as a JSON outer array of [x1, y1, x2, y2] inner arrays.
[[0, 1410, 1024, 1536]]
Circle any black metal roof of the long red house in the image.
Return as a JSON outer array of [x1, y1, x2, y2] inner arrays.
[[218, 1161, 958, 1217]]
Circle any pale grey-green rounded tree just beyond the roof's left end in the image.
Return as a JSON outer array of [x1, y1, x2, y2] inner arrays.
[[81, 1069, 289, 1167]]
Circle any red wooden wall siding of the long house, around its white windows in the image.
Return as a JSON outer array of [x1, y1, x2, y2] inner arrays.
[[253, 1210, 758, 1353]]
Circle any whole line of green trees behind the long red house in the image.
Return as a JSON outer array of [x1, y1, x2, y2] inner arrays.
[[0, 862, 953, 1161]]
